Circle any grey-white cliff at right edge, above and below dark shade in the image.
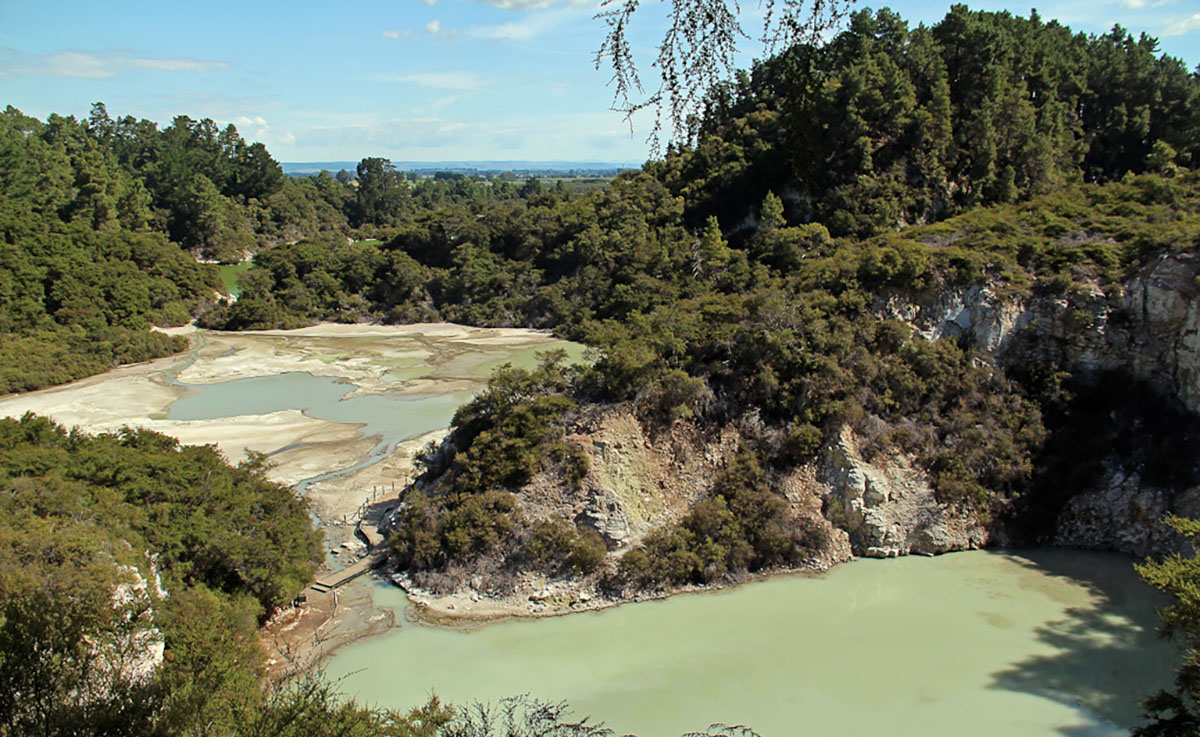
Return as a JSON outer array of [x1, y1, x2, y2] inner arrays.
[[875, 254, 1200, 556]]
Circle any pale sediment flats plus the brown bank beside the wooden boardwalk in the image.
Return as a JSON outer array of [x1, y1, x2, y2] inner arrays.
[[0, 323, 578, 675]]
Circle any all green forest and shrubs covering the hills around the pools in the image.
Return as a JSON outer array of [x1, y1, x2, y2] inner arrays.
[[0, 6, 1200, 736]]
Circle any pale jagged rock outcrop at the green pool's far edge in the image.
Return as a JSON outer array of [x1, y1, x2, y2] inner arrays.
[[817, 429, 988, 558]]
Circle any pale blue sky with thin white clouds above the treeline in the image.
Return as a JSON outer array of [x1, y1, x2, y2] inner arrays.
[[0, 0, 1200, 162]]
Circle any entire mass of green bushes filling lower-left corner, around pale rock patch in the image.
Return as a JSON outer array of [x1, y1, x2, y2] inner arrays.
[[0, 415, 318, 737]]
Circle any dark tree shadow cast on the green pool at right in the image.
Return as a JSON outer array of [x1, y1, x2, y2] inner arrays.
[[989, 550, 1180, 737]]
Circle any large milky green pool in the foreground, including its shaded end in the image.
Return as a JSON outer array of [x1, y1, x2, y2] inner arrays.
[[328, 551, 1175, 737]]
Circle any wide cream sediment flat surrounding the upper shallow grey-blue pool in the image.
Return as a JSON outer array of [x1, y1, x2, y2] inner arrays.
[[0, 323, 568, 492]]
